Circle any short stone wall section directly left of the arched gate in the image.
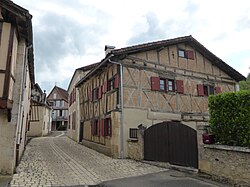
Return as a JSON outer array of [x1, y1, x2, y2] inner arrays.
[[128, 130, 144, 160]]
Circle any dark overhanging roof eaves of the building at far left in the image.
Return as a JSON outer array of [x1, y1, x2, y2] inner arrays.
[[0, 0, 35, 86]]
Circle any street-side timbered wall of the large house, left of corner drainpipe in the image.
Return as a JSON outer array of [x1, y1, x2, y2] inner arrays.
[[79, 65, 121, 157]]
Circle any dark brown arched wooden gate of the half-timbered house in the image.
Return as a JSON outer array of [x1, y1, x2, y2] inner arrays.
[[144, 122, 198, 168]]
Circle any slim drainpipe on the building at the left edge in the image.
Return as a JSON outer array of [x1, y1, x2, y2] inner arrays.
[[16, 44, 32, 163]]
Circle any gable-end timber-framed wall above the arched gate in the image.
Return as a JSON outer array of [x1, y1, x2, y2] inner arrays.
[[122, 44, 237, 156]]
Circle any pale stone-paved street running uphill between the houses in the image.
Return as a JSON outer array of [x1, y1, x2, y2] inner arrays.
[[11, 132, 229, 187]]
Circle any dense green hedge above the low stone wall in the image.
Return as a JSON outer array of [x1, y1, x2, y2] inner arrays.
[[208, 91, 250, 147]]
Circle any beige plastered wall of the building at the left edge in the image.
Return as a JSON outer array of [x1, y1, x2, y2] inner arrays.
[[0, 35, 31, 174]]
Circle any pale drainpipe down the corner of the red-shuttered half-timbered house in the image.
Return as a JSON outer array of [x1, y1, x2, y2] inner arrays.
[[109, 55, 124, 159]]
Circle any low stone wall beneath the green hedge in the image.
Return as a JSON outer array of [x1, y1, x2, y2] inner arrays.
[[199, 145, 250, 184]]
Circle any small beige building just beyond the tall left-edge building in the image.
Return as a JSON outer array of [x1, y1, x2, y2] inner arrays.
[[28, 84, 52, 137]]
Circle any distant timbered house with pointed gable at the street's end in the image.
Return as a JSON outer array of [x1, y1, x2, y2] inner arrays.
[[47, 86, 68, 131]]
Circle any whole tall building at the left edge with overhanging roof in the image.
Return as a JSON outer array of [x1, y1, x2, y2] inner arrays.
[[0, 0, 34, 174]]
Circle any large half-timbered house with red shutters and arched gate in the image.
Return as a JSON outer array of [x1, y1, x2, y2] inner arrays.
[[77, 36, 244, 168]]
